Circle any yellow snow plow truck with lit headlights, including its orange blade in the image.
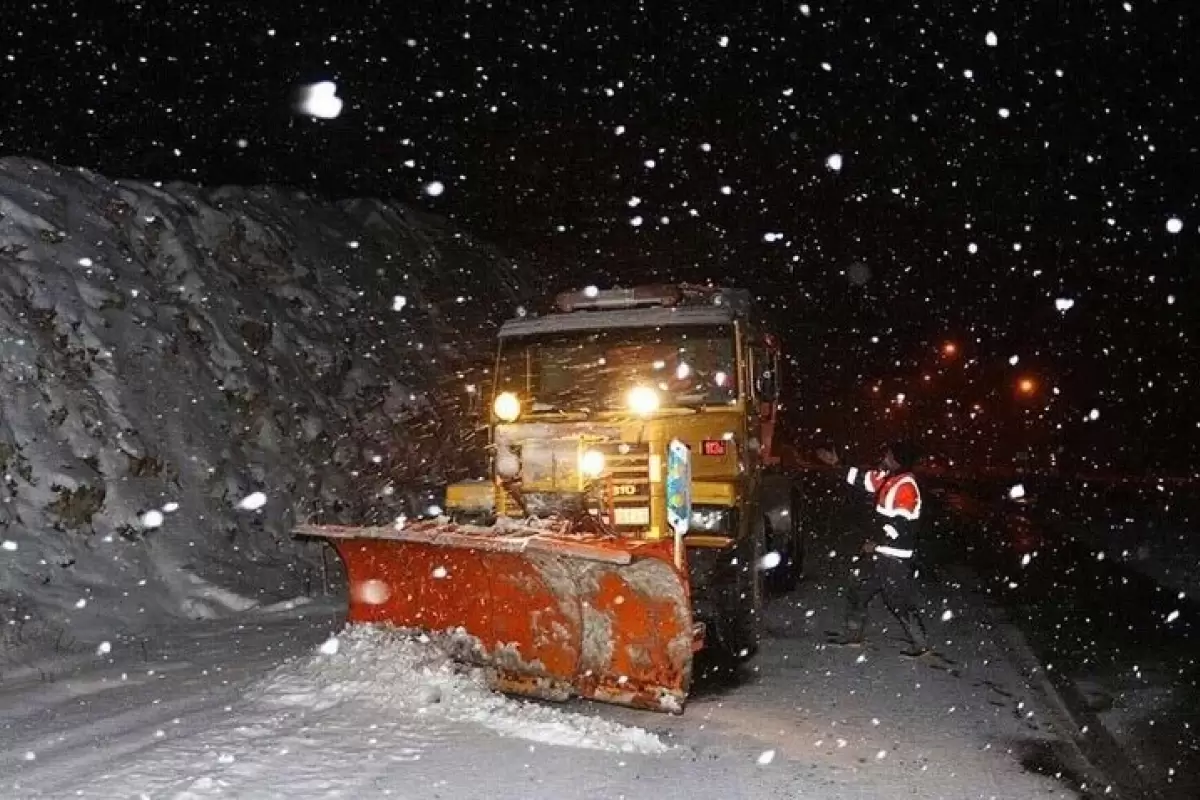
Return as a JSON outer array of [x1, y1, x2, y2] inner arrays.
[[295, 284, 803, 714]]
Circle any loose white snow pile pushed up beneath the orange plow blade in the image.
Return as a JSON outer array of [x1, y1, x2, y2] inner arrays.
[[250, 625, 668, 754]]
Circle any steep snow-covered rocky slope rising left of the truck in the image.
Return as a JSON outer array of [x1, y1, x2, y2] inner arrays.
[[0, 158, 523, 652]]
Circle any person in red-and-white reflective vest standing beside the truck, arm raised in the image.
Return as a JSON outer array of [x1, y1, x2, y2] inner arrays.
[[817, 441, 930, 657]]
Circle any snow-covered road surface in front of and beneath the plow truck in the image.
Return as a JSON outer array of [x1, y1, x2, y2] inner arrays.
[[0, 532, 1078, 800]]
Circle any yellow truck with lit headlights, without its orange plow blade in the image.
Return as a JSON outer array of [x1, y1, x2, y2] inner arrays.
[[446, 284, 803, 658]]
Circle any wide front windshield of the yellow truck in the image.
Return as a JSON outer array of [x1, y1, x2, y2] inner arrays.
[[497, 325, 738, 413]]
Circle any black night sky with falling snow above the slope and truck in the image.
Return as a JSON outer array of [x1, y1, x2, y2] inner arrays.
[[0, 0, 1200, 471]]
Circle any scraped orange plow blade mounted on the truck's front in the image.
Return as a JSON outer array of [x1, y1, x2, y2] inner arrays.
[[295, 522, 695, 714]]
